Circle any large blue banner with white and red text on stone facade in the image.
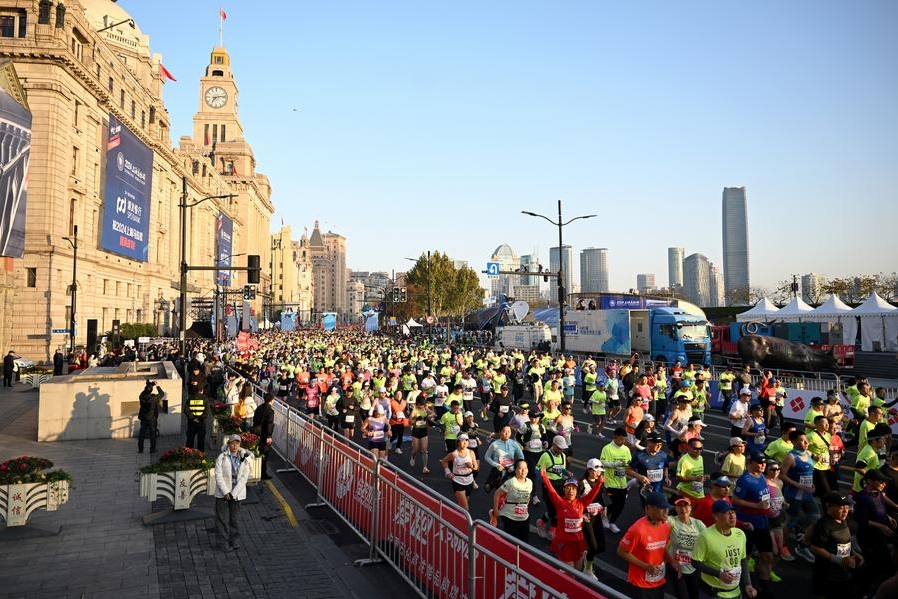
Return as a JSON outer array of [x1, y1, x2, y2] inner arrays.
[[100, 114, 153, 262]]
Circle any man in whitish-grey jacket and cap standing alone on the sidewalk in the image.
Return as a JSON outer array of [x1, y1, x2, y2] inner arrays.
[[215, 435, 254, 552]]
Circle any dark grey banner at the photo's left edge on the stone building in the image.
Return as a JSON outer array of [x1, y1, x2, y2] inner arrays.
[[0, 88, 31, 258]]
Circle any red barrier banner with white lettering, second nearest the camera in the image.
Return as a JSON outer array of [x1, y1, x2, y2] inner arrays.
[[377, 468, 470, 599]]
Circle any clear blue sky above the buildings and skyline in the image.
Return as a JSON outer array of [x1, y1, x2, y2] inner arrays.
[[119, 0, 898, 290]]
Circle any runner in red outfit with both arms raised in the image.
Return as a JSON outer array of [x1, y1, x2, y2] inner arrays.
[[539, 468, 602, 570]]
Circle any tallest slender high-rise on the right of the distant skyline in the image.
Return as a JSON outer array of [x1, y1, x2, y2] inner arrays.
[[723, 187, 750, 306]]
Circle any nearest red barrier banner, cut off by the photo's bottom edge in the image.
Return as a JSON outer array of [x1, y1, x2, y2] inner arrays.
[[473, 524, 605, 599]]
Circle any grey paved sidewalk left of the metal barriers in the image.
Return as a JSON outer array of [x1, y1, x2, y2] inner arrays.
[[0, 384, 380, 599]]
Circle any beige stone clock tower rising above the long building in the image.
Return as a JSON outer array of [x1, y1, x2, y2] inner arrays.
[[193, 46, 255, 177]]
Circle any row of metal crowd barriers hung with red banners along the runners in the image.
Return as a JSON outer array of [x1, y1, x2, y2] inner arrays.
[[262, 386, 626, 599]]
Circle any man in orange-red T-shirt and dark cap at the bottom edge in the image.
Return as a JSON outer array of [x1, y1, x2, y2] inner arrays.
[[617, 491, 676, 599]]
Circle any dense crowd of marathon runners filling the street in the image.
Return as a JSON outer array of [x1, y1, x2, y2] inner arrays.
[[181, 331, 898, 599]]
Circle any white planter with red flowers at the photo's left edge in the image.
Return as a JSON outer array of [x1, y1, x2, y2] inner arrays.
[[0, 456, 72, 526]]
